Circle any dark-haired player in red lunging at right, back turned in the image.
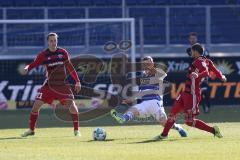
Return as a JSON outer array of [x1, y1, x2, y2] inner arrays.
[[154, 43, 226, 140]]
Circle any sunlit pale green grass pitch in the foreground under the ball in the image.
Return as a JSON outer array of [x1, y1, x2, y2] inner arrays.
[[0, 123, 240, 160]]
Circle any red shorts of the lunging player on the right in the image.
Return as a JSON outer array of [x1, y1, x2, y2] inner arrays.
[[170, 92, 201, 116]]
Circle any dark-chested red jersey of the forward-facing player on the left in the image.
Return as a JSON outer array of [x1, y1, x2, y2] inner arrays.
[[28, 48, 79, 86]]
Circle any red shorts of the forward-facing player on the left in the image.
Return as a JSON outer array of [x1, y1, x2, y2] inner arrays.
[[36, 84, 74, 104]]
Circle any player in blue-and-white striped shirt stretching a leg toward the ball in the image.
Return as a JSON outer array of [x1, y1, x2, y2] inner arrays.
[[111, 56, 187, 137]]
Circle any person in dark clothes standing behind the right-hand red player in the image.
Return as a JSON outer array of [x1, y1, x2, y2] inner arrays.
[[186, 32, 211, 113]]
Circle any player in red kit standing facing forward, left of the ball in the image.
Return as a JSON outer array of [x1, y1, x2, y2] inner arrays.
[[22, 33, 81, 137]]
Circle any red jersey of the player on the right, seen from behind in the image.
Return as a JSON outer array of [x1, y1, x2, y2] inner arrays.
[[185, 56, 222, 97]]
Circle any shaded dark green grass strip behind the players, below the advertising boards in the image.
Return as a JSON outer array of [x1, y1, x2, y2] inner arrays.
[[0, 106, 240, 129]]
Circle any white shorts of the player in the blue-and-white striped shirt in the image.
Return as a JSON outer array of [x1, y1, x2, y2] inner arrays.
[[133, 99, 167, 121]]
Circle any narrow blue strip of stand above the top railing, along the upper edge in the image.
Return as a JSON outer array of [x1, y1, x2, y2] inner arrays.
[[0, 0, 233, 7]]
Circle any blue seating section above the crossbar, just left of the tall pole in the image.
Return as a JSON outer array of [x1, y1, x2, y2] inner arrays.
[[89, 8, 122, 18]]
